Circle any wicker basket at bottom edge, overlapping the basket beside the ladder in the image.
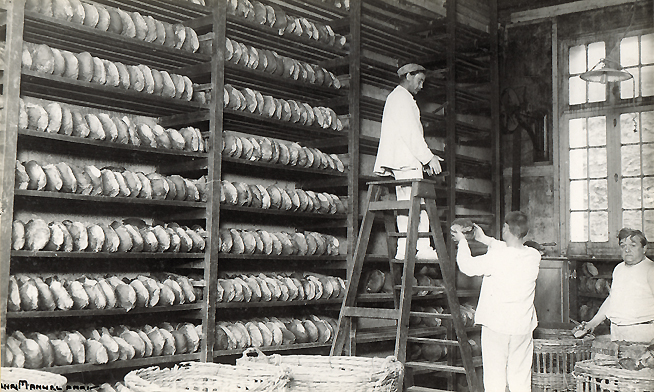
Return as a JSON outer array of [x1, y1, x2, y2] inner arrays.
[[125, 362, 289, 392]]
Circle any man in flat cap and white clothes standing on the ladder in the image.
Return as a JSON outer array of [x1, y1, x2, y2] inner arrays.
[[373, 63, 443, 260]]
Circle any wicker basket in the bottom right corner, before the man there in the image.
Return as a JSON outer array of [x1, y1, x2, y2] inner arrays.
[[573, 360, 654, 392]]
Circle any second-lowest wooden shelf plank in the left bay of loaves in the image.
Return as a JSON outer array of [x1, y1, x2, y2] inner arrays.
[[7, 303, 203, 319]]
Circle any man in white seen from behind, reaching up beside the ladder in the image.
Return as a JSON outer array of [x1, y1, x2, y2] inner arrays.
[[451, 211, 540, 392]]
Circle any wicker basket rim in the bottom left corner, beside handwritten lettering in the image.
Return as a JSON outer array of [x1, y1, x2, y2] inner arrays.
[[0, 367, 68, 391]]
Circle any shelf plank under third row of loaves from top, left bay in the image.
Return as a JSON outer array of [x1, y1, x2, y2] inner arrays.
[[18, 129, 208, 159]]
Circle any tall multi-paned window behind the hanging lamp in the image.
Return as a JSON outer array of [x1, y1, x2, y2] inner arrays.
[[560, 32, 654, 254]]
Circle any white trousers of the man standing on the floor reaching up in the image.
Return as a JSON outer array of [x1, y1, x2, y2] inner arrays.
[[481, 326, 534, 392]]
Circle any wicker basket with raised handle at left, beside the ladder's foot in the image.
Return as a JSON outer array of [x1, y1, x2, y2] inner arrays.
[[236, 348, 404, 392]]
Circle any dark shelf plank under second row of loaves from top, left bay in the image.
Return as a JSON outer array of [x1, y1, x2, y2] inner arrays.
[[21, 70, 208, 116]]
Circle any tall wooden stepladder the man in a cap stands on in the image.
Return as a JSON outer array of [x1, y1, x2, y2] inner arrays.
[[331, 180, 483, 392]]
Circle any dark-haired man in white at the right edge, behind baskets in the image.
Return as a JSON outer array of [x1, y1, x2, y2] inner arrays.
[[574, 228, 654, 343]]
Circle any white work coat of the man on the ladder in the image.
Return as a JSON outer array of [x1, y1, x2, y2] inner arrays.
[[373, 86, 434, 175]]
